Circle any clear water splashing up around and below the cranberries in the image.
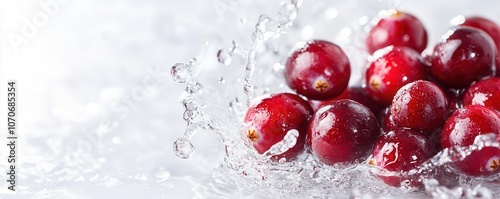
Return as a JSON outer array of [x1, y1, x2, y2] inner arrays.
[[171, 0, 500, 198]]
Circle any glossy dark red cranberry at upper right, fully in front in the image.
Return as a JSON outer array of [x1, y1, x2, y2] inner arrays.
[[430, 27, 496, 89]]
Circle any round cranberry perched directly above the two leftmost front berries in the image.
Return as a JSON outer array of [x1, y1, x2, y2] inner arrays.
[[284, 40, 351, 100]]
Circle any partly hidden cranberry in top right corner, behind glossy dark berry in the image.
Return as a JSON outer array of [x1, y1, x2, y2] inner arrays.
[[460, 16, 500, 77]]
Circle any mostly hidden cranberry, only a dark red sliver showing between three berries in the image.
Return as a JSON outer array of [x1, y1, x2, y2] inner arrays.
[[310, 86, 385, 115]]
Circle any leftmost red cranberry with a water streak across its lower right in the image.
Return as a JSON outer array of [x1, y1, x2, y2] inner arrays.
[[244, 93, 314, 159]]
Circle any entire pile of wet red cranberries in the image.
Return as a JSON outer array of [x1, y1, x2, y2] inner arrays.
[[244, 10, 500, 186]]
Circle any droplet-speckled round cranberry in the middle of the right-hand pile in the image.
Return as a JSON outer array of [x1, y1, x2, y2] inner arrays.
[[391, 80, 449, 135]]
